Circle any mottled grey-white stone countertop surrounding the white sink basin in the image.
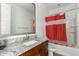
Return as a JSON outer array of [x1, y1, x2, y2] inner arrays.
[[0, 38, 46, 56]]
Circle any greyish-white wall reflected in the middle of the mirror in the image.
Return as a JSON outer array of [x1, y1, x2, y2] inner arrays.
[[11, 5, 33, 33]]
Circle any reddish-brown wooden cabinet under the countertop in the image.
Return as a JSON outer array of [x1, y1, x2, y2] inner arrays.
[[20, 41, 48, 56]]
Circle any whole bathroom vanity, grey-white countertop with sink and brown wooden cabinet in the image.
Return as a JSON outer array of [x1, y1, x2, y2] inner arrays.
[[0, 38, 48, 56]]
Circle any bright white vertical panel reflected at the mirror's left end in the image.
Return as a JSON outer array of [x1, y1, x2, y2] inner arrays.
[[1, 3, 11, 35]]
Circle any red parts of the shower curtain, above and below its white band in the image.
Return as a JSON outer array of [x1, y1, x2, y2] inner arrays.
[[45, 13, 67, 42]]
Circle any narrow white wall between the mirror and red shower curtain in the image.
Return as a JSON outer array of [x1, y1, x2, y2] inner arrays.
[[36, 3, 48, 38]]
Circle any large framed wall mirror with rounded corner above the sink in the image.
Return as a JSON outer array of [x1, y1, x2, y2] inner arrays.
[[0, 3, 35, 36]]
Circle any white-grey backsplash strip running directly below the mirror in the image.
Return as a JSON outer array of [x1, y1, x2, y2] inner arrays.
[[0, 34, 36, 44]]
